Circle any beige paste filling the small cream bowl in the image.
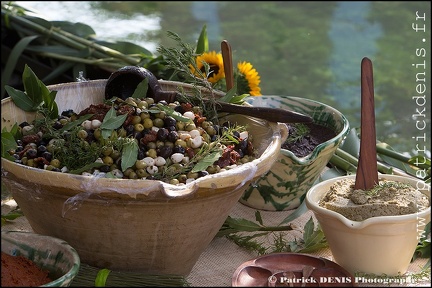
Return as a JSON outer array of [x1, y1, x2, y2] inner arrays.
[[319, 179, 430, 221]]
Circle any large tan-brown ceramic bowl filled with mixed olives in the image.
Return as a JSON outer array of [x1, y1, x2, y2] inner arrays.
[[2, 80, 287, 275]]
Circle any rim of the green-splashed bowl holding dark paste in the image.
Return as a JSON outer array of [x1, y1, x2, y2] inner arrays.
[[245, 95, 350, 165]]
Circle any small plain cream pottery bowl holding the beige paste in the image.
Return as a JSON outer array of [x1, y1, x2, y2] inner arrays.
[[305, 174, 431, 276]]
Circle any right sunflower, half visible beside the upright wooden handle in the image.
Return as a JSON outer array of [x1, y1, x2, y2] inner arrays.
[[237, 61, 261, 96]]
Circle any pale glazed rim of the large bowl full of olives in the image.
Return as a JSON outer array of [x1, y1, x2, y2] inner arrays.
[[1, 79, 288, 199]]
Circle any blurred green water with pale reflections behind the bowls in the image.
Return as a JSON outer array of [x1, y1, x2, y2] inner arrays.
[[14, 1, 431, 157]]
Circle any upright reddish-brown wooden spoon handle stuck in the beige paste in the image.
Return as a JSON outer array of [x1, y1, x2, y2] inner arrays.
[[355, 57, 378, 190]]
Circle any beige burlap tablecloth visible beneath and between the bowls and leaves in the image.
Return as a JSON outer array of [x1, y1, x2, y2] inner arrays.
[[1, 199, 431, 287]]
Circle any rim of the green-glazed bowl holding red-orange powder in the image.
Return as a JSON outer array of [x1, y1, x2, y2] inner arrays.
[[1, 230, 81, 287]]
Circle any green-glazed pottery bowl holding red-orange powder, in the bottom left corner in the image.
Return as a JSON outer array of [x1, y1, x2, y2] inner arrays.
[[1, 231, 80, 287]]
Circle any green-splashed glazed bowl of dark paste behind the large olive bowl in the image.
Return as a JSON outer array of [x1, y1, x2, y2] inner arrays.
[[240, 96, 349, 211]]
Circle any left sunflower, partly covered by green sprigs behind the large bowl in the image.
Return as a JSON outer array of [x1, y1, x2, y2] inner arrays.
[[191, 51, 225, 84]]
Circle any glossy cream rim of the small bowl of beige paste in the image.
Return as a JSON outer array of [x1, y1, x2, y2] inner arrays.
[[305, 174, 431, 229]]
